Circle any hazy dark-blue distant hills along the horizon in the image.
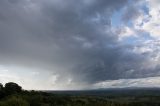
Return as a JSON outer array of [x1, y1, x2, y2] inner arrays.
[[45, 88, 160, 96]]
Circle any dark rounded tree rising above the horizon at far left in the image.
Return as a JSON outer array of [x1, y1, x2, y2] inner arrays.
[[4, 82, 22, 94]]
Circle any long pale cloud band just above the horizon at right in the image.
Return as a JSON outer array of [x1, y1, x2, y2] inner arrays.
[[93, 76, 160, 88]]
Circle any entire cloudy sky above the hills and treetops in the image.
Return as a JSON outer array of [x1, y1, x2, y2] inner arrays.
[[0, 0, 160, 90]]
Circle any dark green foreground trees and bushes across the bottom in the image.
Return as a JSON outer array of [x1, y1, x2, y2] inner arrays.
[[0, 83, 160, 106]]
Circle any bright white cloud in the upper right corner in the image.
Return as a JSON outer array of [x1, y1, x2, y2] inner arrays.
[[134, 0, 160, 39]]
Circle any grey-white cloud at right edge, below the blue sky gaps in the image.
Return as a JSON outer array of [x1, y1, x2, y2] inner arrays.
[[133, 40, 160, 71]]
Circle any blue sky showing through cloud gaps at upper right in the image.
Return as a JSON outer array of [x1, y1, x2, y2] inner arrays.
[[111, 0, 153, 44]]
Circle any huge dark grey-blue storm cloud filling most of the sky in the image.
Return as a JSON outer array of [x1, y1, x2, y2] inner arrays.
[[0, 0, 158, 86]]
